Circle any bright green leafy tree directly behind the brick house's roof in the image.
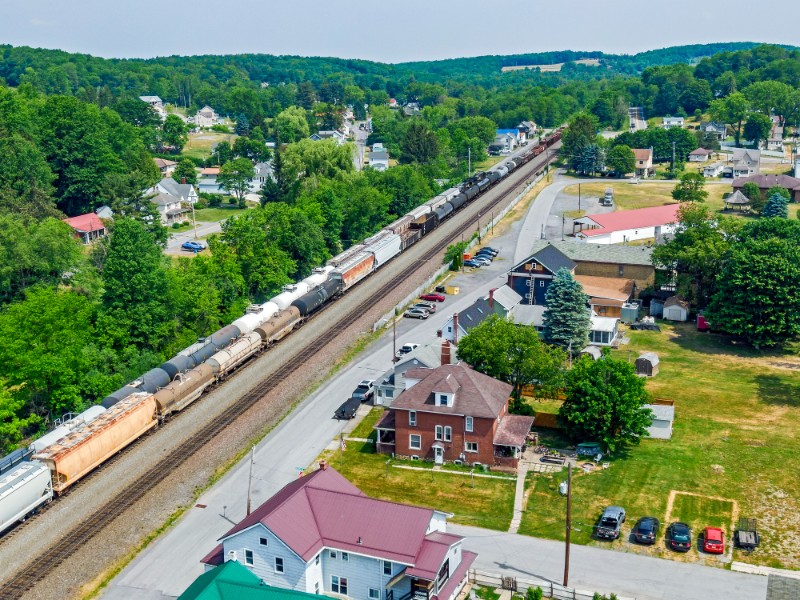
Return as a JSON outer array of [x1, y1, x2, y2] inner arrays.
[[458, 315, 564, 400]]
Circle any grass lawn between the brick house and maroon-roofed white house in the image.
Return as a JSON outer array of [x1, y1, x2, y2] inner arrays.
[[327, 442, 516, 531]]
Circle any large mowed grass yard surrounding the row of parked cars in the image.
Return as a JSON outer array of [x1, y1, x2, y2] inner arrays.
[[520, 323, 800, 569]]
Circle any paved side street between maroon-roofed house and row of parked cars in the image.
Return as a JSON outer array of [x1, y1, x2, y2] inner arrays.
[[448, 525, 767, 600]]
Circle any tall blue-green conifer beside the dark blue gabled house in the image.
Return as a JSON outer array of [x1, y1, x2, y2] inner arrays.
[[544, 268, 590, 354]]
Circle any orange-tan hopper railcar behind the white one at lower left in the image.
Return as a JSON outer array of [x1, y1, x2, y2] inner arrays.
[[33, 392, 158, 494]]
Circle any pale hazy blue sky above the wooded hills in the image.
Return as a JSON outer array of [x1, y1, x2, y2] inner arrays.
[[0, 0, 800, 63]]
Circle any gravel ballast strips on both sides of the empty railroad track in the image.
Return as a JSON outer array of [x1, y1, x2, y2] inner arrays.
[[0, 156, 548, 600]]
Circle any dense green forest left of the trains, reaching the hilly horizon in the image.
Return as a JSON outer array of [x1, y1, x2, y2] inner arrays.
[[0, 44, 800, 451]]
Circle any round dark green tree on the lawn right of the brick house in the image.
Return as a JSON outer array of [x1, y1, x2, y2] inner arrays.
[[558, 357, 652, 452]]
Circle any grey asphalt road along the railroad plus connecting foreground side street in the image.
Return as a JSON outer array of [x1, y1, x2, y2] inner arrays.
[[102, 176, 767, 600]]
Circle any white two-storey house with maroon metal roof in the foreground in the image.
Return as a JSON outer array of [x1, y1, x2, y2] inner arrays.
[[202, 462, 476, 600]]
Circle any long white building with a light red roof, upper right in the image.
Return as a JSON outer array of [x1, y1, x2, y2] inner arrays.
[[575, 204, 680, 244]]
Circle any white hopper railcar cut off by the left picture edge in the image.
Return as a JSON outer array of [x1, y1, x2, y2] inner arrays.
[[0, 462, 53, 533]]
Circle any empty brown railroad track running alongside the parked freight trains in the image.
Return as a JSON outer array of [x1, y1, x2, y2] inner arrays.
[[0, 149, 555, 598]]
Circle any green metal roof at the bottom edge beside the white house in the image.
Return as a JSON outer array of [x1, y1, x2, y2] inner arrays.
[[178, 560, 319, 600]]
